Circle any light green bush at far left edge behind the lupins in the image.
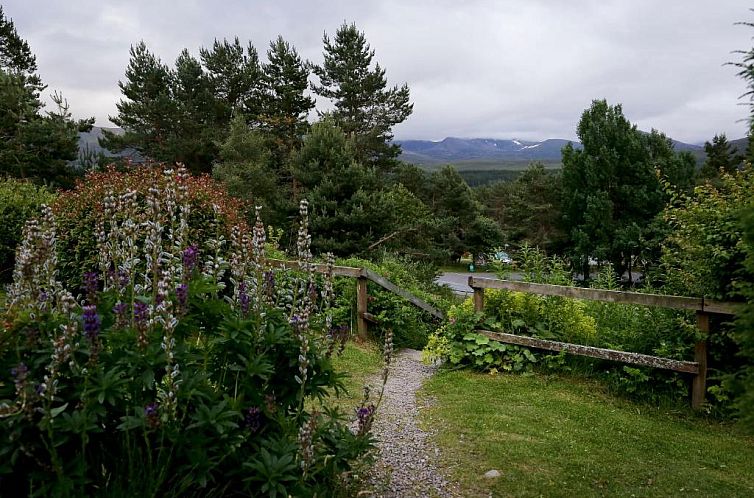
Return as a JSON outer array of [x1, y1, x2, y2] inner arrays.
[[0, 178, 55, 282]]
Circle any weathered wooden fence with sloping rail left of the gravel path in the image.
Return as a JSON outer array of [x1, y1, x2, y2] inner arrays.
[[267, 259, 445, 338]]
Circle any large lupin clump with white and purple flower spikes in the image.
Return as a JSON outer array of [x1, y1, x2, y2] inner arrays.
[[0, 170, 382, 496]]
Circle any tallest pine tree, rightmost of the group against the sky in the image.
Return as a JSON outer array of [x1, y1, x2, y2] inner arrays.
[[312, 23, 413, 170]]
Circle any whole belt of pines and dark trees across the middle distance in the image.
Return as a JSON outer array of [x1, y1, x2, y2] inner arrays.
[[0, 4, 748, 279]]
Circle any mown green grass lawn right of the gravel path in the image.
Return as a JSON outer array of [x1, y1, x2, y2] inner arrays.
[[421, 371, 754, 497]]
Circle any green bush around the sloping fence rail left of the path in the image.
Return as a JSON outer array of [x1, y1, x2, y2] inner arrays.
[[334, 254, 453, 349]]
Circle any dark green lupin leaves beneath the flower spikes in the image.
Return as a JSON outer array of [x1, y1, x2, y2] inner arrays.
[[0, 280, 370, 496]]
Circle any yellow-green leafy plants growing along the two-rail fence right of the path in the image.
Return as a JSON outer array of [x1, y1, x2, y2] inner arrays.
[[426, 245, 714, 402]]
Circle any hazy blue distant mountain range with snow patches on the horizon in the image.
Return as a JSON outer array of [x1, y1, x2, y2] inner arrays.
[[79, 126, 748, 169]]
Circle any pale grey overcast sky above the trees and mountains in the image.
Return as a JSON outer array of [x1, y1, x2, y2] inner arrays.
[[0, 0, 754, 143]]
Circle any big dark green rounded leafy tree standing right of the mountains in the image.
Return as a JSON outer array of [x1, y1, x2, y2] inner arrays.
[[562, 100, 693, 277]]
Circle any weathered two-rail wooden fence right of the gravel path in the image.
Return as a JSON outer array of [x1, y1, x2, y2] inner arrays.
[[469, 276, 736, 410]]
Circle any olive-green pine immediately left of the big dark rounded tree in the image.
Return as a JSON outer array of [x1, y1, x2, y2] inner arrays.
[[477, 163, 563, 252]]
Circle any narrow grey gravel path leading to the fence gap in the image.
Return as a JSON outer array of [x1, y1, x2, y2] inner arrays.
[[364, 349, 459, 497]]
